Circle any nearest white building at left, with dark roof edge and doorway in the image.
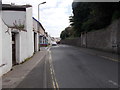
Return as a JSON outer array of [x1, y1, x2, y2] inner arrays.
[[0, 4, 34, 74]]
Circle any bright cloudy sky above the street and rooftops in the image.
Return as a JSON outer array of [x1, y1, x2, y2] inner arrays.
[[2, 0, 73, 37]]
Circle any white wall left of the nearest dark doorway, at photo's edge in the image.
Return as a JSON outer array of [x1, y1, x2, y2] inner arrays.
[[2, 19, 12, 74]]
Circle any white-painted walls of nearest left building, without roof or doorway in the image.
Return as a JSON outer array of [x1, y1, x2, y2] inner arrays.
[[0, 7, 34, 74]]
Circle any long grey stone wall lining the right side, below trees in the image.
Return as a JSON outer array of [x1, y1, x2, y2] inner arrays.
[[61, 19, 120, 53]]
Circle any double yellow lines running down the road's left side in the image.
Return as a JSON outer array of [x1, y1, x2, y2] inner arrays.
[[49, 50, 59, 90]]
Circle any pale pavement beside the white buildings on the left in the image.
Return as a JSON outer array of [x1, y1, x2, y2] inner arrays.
[[2, 50, 46, 88]]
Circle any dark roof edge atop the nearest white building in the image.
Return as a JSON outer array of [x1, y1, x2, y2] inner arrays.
[[2, 4, 32, 11]]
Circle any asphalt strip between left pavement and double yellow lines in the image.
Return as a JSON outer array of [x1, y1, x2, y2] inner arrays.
[[16, 53, 53, 89]]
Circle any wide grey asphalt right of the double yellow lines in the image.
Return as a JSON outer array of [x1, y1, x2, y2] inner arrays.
[[51, 45, 119, 88]]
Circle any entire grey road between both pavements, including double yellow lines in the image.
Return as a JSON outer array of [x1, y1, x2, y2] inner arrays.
[[16, 45, 119, 88]]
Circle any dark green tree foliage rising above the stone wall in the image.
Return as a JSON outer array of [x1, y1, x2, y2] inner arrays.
[[61, 2, 120, 39]]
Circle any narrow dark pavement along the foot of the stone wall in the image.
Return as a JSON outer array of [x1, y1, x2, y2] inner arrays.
[[73, 47, 120, 62]]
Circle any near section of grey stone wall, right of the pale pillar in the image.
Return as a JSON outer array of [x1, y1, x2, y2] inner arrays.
[[86, 20, 120, 53]]
